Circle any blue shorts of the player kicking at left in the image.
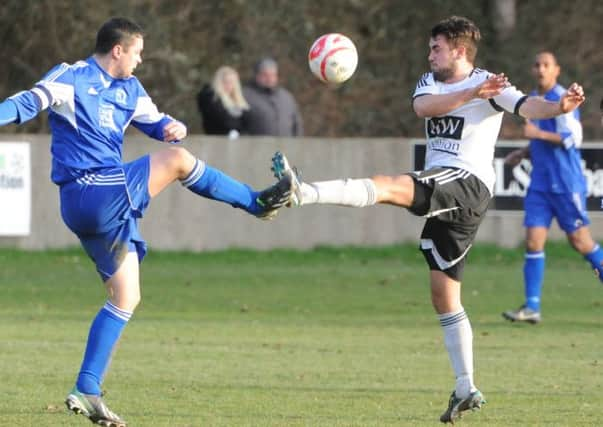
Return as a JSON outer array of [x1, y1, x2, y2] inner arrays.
[[60, 155, 151, 281]]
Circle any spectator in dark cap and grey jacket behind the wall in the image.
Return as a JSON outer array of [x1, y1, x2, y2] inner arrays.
[[243, 58, 304, 136]]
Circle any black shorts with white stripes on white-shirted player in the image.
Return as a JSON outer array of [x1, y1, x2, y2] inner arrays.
[[408, 168, 491, 281]]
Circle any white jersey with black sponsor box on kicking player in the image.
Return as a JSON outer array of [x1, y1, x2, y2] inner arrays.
[[413, 68, 527, 194]]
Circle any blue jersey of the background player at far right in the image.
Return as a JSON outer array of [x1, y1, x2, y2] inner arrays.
[[530, 85, 586, 193]]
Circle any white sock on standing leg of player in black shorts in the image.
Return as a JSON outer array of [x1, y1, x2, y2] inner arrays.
[[438, 307, 477, 399]]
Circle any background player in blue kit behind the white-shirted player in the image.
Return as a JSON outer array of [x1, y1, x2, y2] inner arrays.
[[503, 52, 603, 323]]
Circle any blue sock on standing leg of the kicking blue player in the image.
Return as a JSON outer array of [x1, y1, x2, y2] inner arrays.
[[76, 301, 132, 396]]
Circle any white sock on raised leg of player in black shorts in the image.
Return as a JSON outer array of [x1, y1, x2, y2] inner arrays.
[[300, 178, 377, 208]]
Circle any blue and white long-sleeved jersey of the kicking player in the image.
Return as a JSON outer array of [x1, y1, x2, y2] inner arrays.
[[10, 57, 174, 184]]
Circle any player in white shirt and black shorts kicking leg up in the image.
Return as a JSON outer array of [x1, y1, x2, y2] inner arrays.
[[272, 16, 584, 423]]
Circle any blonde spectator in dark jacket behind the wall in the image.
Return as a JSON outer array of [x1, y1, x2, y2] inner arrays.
[[197, 66, 249, 138]]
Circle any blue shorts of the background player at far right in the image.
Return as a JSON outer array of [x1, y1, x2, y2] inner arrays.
[[523, 189, 590, 234]]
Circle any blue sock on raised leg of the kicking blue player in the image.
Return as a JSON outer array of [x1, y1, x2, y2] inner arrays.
[[181, 160, 263, 215]]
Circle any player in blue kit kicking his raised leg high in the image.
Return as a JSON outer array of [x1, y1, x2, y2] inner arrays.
[[0, 18, 291, 427]]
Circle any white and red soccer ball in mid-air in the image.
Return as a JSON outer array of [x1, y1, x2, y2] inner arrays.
[[308, 33, 358, 84]]
